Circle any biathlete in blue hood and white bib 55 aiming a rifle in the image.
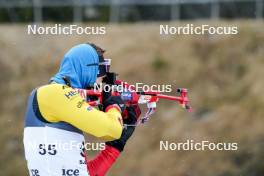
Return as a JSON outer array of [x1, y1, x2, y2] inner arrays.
[[23, 43, 140, 176]]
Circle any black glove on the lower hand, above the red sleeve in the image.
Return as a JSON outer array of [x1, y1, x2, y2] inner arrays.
[[105, 107, 137, 152]]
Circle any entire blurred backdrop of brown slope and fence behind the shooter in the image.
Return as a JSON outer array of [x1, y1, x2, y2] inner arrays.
[[0, 0, 264, 176]]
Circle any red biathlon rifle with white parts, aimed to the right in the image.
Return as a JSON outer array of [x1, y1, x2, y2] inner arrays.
[[79, 72, 192, 124]]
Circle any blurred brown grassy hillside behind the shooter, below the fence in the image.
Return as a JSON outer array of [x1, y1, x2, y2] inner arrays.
[[0, 21, 264, 176]]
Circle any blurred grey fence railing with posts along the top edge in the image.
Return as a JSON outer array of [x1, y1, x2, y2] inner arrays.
[[0, 0, 264, 23]]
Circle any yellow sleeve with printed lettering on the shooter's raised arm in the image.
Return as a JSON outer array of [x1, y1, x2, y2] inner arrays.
[[37, 84, 122, 140]]
